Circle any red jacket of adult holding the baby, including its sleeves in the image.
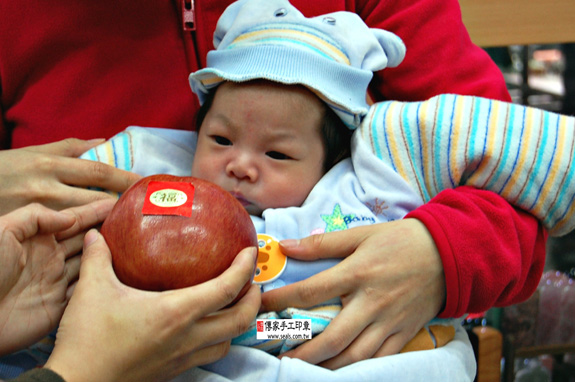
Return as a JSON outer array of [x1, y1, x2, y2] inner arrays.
[[0, 0, 545, 316]]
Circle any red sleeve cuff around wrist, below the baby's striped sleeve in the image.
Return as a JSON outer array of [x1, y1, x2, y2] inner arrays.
[[406, 186, 546, 317]]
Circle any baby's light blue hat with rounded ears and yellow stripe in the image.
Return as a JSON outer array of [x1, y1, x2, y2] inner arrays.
[[189, 0, 405, 129]]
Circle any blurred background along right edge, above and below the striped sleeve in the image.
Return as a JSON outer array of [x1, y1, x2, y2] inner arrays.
[[459, 0, 575, 382]]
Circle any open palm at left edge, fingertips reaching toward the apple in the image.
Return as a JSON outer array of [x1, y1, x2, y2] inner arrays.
[[0, 199, 114, 354]]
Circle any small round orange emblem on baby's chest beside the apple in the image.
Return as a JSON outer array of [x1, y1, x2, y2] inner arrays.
[[254, 234, 287, 284]]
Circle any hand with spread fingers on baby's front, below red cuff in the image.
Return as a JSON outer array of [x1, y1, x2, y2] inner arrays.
[[262, 219, 446, 369]]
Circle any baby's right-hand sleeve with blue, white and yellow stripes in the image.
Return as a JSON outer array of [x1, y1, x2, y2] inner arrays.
[[358, 94, 575, 236]]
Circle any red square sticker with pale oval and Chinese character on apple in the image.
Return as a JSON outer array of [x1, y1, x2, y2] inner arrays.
[[142, 181, 194, 217]]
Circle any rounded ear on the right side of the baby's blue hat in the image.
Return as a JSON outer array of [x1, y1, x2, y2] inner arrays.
[[362, 28, 406, 72]]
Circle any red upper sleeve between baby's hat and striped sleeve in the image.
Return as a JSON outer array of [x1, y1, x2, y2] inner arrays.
[[357, 0, 511, 101]]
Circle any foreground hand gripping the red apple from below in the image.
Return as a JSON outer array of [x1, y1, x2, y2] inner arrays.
[[46, 230, 260, 382]]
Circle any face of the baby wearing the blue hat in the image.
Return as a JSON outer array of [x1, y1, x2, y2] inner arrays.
[[192, 81, 325, 216]]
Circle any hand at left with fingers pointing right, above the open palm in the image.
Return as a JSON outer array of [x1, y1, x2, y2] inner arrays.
[[0, 138, 140, 215]]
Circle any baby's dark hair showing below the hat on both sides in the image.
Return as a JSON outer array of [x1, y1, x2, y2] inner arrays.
[[196, 83, 352, 173]]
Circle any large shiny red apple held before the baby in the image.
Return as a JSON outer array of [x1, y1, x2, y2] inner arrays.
[[102, 175, 257, 298]]
